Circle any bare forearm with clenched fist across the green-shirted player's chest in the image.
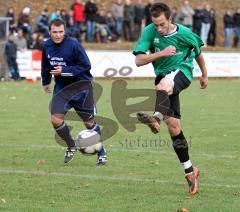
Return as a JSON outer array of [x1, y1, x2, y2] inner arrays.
[[135, 46, 176, 66]]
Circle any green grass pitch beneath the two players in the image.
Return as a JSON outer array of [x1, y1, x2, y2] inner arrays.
[[0, 80, 240, 212]]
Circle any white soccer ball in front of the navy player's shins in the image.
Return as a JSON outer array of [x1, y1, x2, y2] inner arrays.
[[76, 130, 102, 155]]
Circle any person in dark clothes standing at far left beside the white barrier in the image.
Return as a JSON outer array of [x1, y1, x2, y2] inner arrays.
[[4, 34, 20, 80]]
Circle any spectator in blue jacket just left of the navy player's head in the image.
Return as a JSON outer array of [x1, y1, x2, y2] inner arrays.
[[36, 9, 49, 37]]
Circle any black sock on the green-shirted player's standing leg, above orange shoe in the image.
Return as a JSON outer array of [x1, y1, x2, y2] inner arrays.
[[171, 131, 193, 173]]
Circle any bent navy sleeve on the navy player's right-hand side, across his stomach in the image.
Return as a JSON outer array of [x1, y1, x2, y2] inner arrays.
[[62, 42, 91, 76]]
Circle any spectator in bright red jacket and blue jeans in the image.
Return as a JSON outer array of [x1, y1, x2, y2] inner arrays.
[[71, 0, 85, 40]]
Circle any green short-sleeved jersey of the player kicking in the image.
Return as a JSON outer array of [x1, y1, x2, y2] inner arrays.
[[133, 24, 204, 81]]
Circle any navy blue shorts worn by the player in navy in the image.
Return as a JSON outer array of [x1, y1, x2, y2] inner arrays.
[[50, 81, 96, 121]]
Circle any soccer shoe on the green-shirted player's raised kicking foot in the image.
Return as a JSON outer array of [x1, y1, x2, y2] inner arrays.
[[137, 112, 160, 134]]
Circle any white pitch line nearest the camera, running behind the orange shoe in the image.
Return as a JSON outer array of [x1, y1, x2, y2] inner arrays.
[[0, 168, 240, 188]]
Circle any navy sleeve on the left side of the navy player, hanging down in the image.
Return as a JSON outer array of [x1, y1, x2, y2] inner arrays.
[[41, 49, 52, 85]]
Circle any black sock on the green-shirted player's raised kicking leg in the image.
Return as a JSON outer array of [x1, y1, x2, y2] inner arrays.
[[155, 90, 173, 116]]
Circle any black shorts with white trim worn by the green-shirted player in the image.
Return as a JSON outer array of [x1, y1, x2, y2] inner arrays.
[[155, 70, 191, 119]]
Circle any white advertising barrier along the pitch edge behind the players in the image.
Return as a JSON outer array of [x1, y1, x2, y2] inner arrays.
[[17, 51, 240, 78]]
